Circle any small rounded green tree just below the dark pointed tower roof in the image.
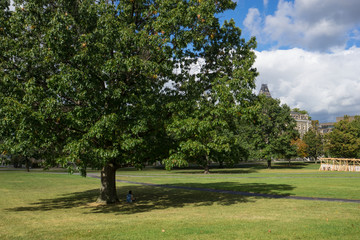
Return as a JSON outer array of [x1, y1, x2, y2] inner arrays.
[[251, 95, 299, 168]]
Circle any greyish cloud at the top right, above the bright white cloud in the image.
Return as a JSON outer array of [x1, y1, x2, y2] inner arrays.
[[244, 0, 360, 51]]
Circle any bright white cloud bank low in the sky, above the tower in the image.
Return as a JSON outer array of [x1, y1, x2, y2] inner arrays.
[[255, 47, 360, 122]]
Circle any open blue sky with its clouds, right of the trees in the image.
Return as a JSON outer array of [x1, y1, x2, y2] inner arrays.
[[219, 0, 360, 122]]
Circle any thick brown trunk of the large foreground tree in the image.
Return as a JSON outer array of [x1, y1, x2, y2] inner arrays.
[[97, 163, 119, 204]]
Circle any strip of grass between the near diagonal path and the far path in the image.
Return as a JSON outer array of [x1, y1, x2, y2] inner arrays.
[[114, 176, 360, 200]]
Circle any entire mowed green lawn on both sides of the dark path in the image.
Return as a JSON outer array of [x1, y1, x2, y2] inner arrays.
[[0, 164, 360, 239]]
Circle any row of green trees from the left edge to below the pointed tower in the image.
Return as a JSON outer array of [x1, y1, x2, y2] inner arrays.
[[0, 0, 306, 203]]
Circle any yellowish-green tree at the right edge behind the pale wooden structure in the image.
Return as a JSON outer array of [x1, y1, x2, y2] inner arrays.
[[326, 116, 360, 158]]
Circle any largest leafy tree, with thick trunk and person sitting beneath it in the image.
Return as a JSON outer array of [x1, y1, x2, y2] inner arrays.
[[0, 0, 242, 203]]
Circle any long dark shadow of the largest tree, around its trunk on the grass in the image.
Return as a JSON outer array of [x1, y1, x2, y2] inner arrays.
[[7, 182, 294, 214]]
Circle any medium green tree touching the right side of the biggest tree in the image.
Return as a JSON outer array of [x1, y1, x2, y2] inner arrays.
[[167, 18, 257, 173]]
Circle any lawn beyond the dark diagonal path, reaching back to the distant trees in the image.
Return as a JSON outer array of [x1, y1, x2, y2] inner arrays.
[[117, 163, 360, 200]]
